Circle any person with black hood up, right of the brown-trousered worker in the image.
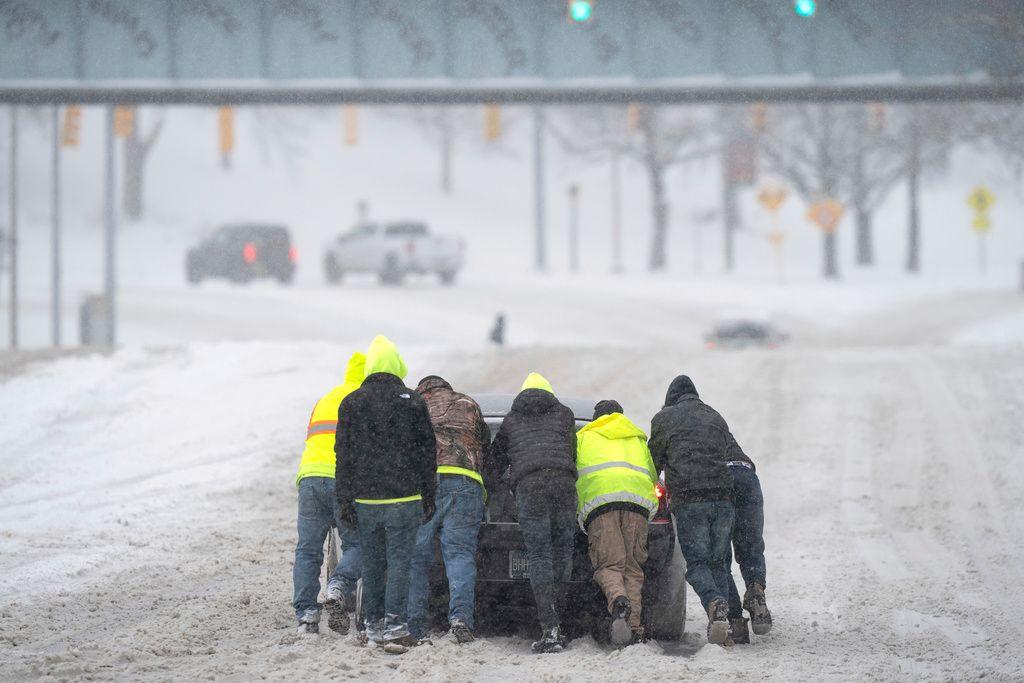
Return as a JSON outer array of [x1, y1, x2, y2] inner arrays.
[[649, 375, 735, 645]]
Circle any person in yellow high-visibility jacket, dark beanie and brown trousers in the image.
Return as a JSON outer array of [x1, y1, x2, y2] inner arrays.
[[577, 400, 657, 646]]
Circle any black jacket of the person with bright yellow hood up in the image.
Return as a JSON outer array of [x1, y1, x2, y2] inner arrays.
[[334, 373, 437, 507]]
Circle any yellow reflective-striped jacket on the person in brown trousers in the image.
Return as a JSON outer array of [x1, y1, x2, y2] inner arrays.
[[577, 413, 657, 528]]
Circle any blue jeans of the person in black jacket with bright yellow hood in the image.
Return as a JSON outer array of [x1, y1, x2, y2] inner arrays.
[[355, 501, 423, 632]]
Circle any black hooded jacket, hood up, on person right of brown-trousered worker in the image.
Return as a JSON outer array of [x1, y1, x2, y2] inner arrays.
[[648, 375, 742, 508]]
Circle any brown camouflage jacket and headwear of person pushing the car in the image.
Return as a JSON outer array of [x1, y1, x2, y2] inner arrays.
[[416, 376, 490, 478]]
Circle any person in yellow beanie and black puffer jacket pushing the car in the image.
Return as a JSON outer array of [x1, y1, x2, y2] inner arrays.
[[490, 373, 575, 652]]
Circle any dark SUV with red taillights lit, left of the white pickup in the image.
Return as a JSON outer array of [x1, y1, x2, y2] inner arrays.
[[185, 223, 298, 285]]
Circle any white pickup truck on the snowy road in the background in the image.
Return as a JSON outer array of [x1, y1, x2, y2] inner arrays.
[[324, 221, 466, 285]]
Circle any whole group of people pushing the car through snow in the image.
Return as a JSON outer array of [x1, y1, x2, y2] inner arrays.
[[293, 336, 771, 653]]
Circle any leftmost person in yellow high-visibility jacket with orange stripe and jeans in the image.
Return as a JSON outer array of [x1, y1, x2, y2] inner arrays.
[[292, 352, 366, 633]]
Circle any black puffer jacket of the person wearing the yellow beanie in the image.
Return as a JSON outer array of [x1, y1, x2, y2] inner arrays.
[[490, 389, 575, 490]]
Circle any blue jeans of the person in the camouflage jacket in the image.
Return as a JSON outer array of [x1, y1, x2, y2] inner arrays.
[[409, 474, 483, 638]]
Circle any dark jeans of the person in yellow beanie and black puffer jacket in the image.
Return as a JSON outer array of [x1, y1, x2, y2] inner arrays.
[[515, 475, 578, 631]]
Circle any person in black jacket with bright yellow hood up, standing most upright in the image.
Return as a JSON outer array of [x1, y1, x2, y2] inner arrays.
[[335, 336, 437, 652]]
